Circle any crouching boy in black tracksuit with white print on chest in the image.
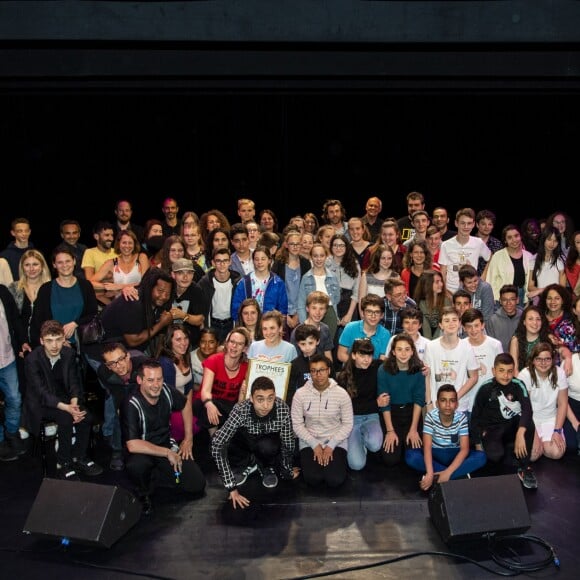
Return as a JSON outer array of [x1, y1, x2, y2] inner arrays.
[[470, 352, 538, 489]]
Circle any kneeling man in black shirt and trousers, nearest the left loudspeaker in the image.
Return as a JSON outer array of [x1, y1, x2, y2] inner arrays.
[[121, 359, 205, 515]]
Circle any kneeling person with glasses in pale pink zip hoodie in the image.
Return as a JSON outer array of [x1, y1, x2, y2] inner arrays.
[[291, 354, 354, 487]]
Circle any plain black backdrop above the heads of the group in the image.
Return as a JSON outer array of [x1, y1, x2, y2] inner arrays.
[[0, 91, 580, 249]]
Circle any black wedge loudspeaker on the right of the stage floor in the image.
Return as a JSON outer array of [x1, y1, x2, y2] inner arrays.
[[428, 475, 532, 543]]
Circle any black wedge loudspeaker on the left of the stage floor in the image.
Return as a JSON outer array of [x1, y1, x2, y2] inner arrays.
[[22, 478, 142, 548]]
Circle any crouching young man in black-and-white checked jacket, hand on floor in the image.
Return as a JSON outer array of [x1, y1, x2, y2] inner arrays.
[[211, 377, 299, 509]]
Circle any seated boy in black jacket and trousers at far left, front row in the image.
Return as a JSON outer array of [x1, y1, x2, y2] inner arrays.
[[24, 320, 103, 480]]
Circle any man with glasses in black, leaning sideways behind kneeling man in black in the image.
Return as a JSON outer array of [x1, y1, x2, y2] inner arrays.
[[97, 342, 146, 471]]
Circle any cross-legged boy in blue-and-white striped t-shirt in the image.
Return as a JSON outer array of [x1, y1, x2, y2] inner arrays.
[[405, 384, 486, 491]]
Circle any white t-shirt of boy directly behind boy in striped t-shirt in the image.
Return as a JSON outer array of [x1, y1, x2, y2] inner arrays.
[[424, 337, 479, 411]]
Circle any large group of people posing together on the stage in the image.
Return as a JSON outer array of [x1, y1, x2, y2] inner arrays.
[[0, 197, 580, 512]]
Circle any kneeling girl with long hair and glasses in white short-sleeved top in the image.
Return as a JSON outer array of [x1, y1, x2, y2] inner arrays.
[[518, 342, 568, 461]]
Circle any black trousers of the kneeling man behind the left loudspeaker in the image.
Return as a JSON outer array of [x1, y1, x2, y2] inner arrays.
[[126, 453, 205, 496]]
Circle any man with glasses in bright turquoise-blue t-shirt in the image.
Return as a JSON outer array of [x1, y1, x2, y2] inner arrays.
[[336, 294, 391, 363]]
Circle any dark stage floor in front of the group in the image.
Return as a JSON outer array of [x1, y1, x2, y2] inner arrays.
[[0, 428, 580, 580]]
